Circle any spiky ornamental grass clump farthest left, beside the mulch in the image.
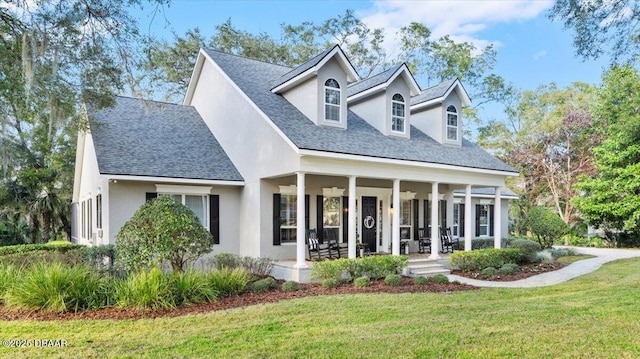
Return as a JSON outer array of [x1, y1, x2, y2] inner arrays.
[[3, 262, 110, 313]]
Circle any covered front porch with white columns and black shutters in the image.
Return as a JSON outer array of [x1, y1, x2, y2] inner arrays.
[[265, 171, 506, 269]]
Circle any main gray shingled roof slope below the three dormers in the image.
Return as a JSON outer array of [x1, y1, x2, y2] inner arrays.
[[205, 49, 517, 172]]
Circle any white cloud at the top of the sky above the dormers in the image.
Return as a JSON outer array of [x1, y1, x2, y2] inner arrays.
[[358, 0, 553, 50]]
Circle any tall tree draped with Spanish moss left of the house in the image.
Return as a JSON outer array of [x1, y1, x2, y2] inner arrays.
[[0, 0, 164, 241]]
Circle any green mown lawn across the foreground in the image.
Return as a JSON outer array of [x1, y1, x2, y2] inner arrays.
[[0, 259, 640, 358]]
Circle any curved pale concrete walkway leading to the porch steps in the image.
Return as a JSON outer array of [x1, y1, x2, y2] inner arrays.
[[447, 247, 640, 288]]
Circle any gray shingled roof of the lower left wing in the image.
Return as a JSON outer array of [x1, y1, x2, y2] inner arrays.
[[90, 96, 243, 181]]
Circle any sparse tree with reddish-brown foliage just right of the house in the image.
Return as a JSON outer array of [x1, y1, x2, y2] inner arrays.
[[479, 83, 601, 235]]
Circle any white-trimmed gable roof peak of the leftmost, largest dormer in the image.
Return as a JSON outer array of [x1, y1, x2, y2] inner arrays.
[[271, 45, 360, 93]]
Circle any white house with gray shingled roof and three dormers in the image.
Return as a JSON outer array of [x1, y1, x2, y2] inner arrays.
[[73, 46, 517, 282]]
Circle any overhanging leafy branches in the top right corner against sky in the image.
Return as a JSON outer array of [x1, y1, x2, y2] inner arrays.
[[549, 0, 640, 63]]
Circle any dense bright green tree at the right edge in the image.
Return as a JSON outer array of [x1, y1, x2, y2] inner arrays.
[[575, 66, 640, 238]]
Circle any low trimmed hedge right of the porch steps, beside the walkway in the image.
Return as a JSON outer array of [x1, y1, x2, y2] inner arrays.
[[449, 248, 522, 271]]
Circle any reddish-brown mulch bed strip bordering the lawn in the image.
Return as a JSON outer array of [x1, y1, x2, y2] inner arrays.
[[0, 263, 564, 321]]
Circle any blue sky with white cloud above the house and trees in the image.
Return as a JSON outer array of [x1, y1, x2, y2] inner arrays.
[[140, 0, 606, 122]]
